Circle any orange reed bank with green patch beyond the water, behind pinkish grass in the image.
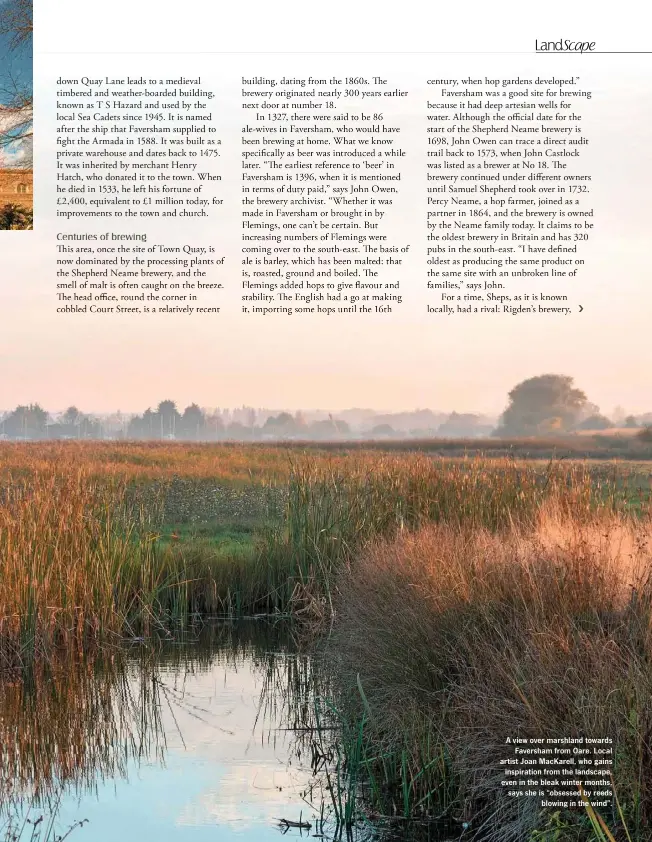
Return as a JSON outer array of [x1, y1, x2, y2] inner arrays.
[[0, 443, 640, 669]]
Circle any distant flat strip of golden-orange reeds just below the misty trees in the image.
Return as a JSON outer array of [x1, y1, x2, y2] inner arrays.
[[0, 436, 652, 486]]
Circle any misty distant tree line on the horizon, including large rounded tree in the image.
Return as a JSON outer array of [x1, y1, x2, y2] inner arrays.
[[0, 374, 652, 441]]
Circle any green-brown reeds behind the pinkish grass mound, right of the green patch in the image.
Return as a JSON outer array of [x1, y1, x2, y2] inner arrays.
[[267, 454, 627, 616]]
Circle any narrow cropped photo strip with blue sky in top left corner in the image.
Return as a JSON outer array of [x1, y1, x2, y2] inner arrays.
[[0, 0, 33, 231]]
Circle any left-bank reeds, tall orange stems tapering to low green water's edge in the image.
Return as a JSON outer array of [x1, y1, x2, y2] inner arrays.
[[0, 465, 300, 676]]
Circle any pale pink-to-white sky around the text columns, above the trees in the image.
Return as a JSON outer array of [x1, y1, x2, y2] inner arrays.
[[0, 0, 652, 413]]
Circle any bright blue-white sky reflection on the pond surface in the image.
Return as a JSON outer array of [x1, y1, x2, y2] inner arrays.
[[5, 624, 338, 842]]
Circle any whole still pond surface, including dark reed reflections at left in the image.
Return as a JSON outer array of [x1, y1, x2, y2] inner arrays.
[[0, 622, 354, 842]]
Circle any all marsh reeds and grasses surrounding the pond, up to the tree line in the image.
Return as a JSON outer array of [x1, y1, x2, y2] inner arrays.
[[0, 443, 652, 842]]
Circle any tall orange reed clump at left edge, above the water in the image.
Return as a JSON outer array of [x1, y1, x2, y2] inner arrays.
[[0, 470, 148, 667]]
